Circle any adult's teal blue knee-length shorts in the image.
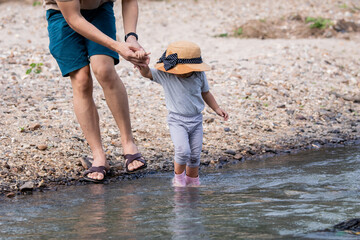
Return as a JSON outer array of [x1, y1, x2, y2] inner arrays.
[[46, 2, 119, 77]]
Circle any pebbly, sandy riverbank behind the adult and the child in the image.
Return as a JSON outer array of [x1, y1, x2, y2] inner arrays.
[[0, 0, 360, 196]]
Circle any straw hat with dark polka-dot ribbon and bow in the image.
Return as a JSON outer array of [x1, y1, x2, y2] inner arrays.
[[155, 41, 211, 74]]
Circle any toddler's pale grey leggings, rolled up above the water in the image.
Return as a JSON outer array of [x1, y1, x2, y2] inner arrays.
[[167, 113, 203, 167]]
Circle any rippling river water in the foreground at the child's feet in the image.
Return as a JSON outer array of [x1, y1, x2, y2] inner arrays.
[[0, 146, 360, 240]]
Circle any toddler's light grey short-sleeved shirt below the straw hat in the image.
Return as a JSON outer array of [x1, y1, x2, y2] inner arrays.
[[150, 68, 209, 116]]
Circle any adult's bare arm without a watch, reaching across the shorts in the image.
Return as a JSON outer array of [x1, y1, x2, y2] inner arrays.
[[57, 0, 143, 65]]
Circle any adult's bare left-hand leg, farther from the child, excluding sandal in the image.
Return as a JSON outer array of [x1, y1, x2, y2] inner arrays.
[[70, 66, 109, 180]]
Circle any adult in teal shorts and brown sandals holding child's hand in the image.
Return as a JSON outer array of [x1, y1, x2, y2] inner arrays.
[[44, 0, 149, 182]]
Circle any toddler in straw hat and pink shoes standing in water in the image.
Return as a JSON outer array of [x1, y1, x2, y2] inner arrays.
[[139, 41, 228, 187]]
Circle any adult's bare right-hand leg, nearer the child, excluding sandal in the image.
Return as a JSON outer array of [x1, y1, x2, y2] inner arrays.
[[90, 55, 143, 171]]
